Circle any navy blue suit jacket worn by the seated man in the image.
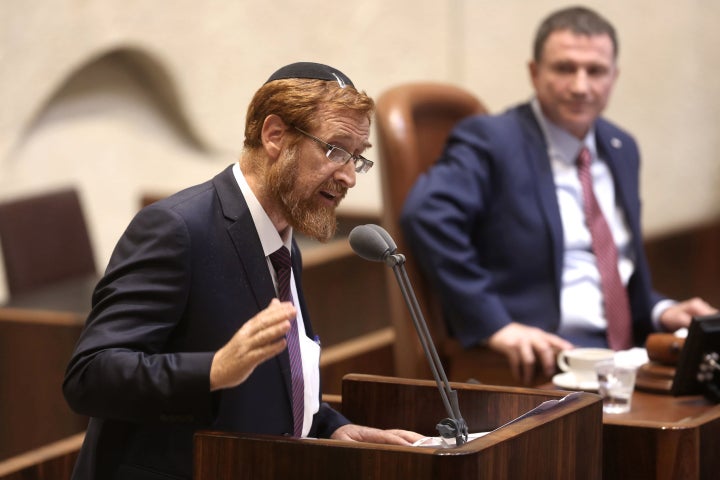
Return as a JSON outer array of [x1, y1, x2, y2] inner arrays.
[[401, 104, 661, 346]]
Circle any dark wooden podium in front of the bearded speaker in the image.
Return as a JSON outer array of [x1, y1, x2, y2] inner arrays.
[[194, 374, 602, 480]]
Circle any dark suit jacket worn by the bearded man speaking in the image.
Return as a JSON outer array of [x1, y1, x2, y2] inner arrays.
[[63, 168, 349, 480]]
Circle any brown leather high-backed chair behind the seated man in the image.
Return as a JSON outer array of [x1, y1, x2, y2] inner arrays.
[[376, 83, 546, 385]]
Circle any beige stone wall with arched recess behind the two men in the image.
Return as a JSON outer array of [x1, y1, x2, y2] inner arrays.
[[0, 0, 720, 298]]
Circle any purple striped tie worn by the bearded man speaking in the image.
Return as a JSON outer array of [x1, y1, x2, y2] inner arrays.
[[270, 247, 305, 437]]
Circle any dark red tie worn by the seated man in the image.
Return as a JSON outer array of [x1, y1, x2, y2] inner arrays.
[[577, 147, 633, 350]]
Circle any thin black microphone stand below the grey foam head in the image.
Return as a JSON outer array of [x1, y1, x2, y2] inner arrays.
[[384, 253, 468, 446]]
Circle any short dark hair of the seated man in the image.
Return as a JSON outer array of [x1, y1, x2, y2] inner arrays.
[[533, 7, 618, 62]]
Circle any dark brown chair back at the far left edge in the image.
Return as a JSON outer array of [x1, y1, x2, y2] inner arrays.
[[0, 188, 97, 299]]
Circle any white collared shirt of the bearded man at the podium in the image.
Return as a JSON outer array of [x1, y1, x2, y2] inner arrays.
[[233, 163, 320, 437]]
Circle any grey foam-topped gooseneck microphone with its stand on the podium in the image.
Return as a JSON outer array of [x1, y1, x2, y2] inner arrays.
[[349, 224, 468, 446]]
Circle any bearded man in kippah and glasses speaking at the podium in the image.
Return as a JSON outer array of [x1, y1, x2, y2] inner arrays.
[[63, 62, 421, 480]]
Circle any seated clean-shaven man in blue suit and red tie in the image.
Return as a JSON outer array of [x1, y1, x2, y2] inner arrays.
[[401, 7, 714, 383]]
